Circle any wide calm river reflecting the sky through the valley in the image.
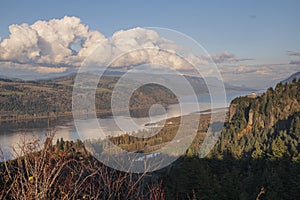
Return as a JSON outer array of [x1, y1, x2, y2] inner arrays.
[[0, 91, 253, 160]]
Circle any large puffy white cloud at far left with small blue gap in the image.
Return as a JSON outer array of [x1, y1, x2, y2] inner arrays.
[[0, 16, 105, 71]]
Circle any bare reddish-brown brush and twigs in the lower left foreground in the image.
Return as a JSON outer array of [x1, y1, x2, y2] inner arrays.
[[0, 134, 164, 200]]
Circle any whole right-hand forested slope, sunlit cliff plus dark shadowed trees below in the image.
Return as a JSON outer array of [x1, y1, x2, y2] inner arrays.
[[161, 80, 300, 200]]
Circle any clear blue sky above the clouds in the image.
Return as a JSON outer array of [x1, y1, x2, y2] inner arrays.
[[0, 0, 300, 63]]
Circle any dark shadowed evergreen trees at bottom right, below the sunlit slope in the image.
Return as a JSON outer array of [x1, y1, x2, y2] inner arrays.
[[160, 155, 300, 200]]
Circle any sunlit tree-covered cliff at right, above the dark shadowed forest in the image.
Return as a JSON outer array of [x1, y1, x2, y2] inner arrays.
[[217, 80, 300, 161]]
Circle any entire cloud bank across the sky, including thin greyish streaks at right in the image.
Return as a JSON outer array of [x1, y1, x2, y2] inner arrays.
[[0, 16, 292, 89]]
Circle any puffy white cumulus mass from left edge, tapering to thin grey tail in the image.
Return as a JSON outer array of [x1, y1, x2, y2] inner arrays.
[[0, 16, 249, 78]]
